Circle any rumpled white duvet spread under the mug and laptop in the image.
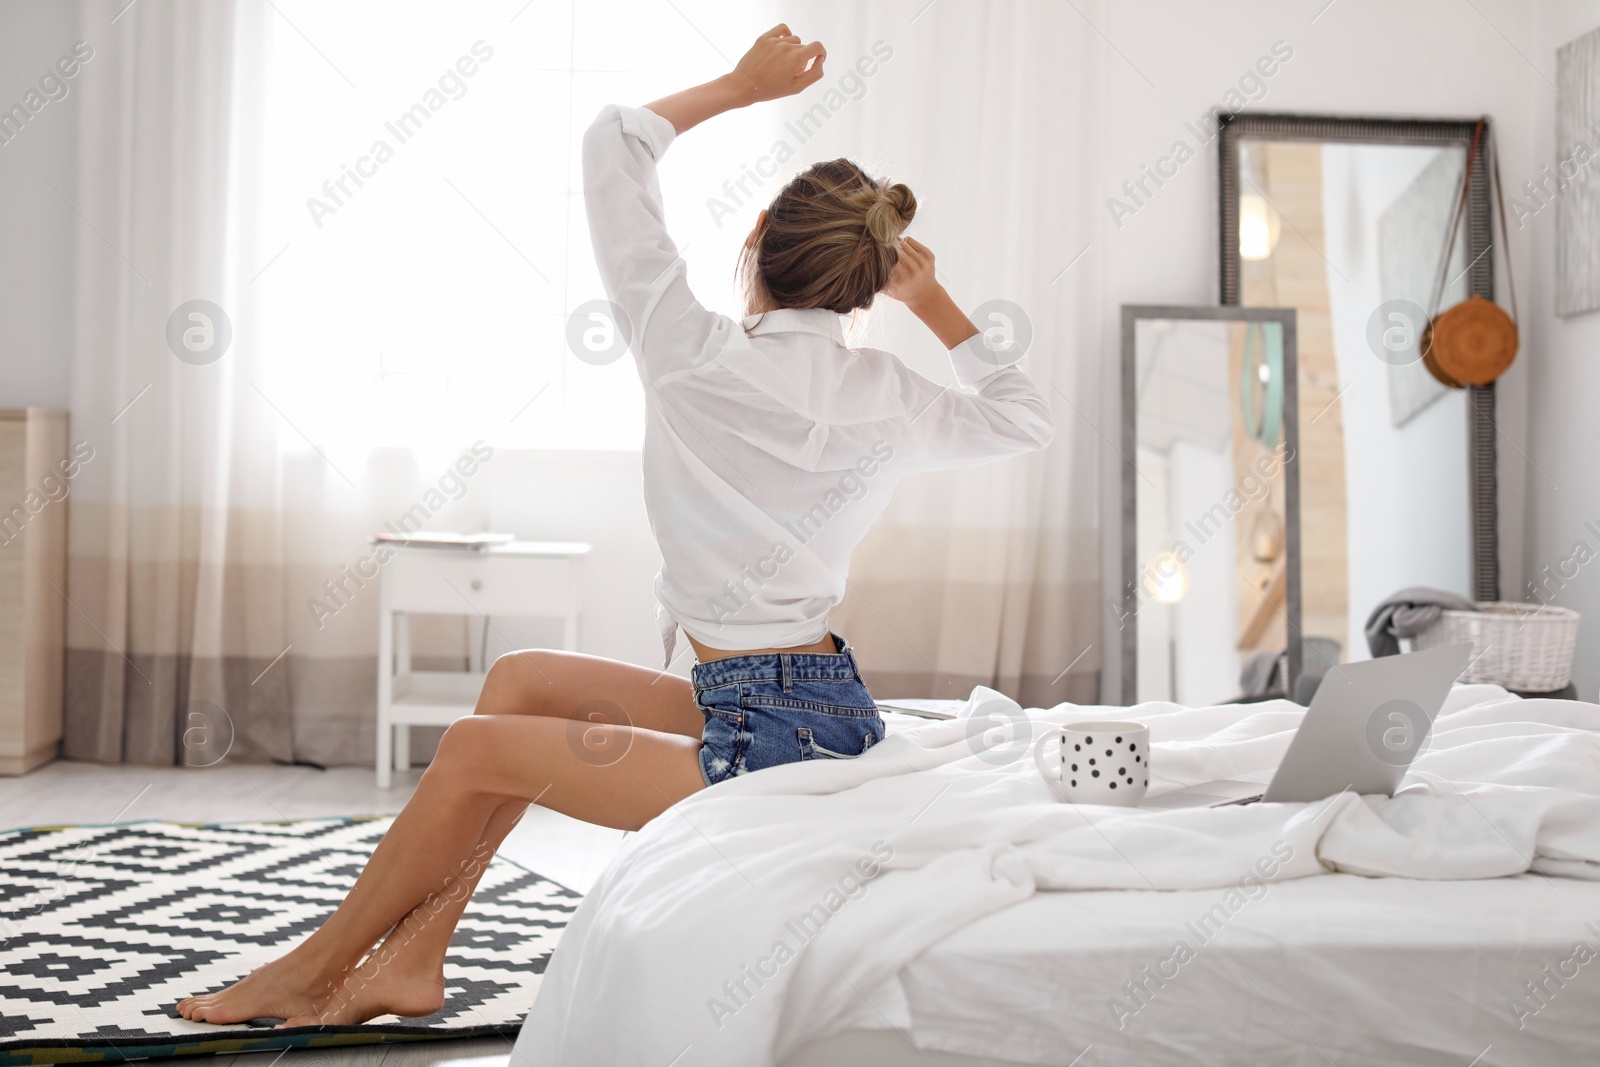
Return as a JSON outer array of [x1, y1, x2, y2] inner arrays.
[[514, 686, 1600, 1067]]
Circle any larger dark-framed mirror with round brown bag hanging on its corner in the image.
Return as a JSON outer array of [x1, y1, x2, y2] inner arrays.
[[1219, 112, 1499, 687]]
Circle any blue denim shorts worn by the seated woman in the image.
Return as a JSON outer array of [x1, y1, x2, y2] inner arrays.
[[693, 633, 883, 785]]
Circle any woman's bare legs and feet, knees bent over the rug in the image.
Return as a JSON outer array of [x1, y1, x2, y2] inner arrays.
[[178, 653, 702, 1022]]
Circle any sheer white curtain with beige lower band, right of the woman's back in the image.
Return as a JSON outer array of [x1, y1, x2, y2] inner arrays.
[[797, 0, 1112, 705]]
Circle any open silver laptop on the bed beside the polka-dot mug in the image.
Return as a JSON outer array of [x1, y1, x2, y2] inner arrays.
[[1139, 645, 1472, 808]]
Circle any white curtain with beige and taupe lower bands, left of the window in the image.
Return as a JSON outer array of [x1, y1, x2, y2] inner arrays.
[[61, 0, 486, 766]]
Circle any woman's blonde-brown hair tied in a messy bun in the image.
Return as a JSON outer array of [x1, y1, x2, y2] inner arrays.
[[739, 160, 917, 315]]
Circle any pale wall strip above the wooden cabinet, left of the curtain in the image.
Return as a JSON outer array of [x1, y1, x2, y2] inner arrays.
[[0, 3, 80, 408]]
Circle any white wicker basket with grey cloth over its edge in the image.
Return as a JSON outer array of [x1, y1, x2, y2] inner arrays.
[[1411, 600, 1579, 693]]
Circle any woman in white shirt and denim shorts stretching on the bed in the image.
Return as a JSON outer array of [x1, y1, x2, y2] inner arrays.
[[178, 26, 1053, 1025]]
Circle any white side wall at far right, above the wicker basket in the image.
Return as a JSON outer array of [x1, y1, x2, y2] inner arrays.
[[1506, 0, 1600, 701]]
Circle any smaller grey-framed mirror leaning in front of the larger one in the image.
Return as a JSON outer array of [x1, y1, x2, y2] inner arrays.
[[1118, 306, 1304, 705]]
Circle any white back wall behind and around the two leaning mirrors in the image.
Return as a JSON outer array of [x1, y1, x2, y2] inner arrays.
[[1094, 0, 1542, 699]]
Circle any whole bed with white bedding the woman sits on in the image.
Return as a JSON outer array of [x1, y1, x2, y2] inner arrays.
[[514, 686, 1600, 1067]]
